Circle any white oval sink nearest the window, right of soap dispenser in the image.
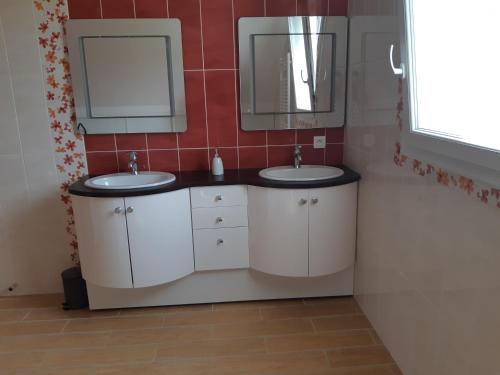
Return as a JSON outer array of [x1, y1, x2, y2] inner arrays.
[[259, 165, 344, 181]]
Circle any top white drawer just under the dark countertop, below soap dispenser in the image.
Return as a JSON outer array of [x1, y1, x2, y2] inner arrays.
[[191, 185, 247, 208]]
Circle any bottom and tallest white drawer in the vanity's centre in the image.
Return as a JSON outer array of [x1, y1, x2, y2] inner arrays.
[[193, 228, 249, 271]]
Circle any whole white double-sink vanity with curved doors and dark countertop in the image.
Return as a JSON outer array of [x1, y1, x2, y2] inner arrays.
[[70, 165, 359, 309]]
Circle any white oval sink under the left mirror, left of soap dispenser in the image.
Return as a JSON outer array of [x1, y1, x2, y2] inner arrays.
[[85, 172, 175, 190]]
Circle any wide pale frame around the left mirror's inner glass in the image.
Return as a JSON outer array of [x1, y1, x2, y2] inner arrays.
[[66, 18, 187, 134]]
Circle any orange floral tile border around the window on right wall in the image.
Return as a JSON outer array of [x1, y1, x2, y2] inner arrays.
[[394, 79, 500, 208]]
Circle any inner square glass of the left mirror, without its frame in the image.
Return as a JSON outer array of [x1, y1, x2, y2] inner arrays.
[[82, 37, 172, 117]]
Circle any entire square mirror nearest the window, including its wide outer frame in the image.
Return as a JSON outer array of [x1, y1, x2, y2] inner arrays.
[[239, 17, 347, 130]]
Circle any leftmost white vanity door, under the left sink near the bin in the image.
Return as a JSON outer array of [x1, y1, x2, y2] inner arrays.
[[72, 195, 132, 288]]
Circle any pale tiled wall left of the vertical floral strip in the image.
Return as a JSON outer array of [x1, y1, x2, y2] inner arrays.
[[0, 0, 71, 295]]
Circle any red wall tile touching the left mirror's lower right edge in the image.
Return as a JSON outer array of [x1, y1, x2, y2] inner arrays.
[[179, 72, 208, 148]]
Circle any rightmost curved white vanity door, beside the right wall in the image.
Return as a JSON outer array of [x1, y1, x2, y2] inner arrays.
[[309, 183, 357, 276]]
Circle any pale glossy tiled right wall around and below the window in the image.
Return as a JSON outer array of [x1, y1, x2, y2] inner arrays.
[[344, 0, 500, 375]]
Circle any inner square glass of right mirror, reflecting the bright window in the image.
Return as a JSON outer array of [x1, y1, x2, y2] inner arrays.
[[253, 30, 333, 113]]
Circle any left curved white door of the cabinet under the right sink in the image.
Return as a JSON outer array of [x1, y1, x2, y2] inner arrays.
[[248, 186, 309, 277]]
